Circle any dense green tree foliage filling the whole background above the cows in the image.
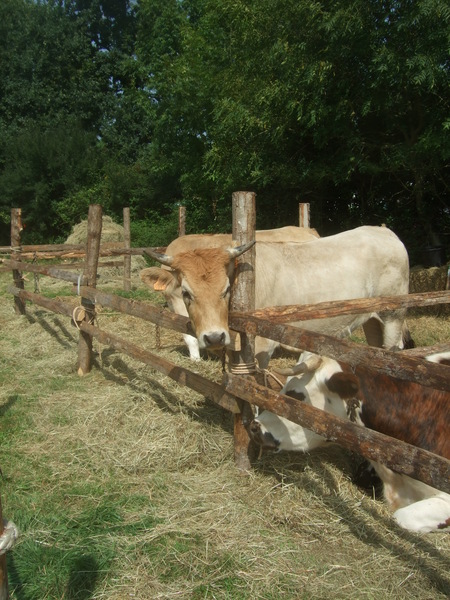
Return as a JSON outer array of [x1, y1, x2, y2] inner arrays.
[[0, 0, 450, 256]]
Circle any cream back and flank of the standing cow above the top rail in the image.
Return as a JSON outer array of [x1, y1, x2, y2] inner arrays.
[[255, 226, 409, 308]]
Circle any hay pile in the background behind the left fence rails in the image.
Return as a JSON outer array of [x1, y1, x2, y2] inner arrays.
[[65, 215, 146, 283]]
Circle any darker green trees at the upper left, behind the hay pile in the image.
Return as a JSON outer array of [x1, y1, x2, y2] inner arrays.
[[0, 0, 140, 241]]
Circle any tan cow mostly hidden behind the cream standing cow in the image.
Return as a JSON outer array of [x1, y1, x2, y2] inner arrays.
[[141, 225, 320, 360]]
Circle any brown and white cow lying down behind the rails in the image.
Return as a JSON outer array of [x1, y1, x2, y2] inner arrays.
[[249, 352, 450, 533]]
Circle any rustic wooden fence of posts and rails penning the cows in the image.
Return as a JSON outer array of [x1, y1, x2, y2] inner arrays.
[[3, 202, 450, 493]]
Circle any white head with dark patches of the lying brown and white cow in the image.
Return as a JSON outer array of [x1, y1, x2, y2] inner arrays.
[[249, 352, 358, 452]]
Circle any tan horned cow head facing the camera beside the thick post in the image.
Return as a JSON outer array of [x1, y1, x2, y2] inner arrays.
[[141, 242, 255, 349]]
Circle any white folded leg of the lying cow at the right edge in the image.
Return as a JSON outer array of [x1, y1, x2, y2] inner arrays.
[[394, 496, 450, 533]]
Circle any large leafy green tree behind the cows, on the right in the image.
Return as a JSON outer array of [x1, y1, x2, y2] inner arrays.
[[142, 0, 449, 251]]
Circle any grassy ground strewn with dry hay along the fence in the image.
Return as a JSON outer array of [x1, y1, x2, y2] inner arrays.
[[0, 274, 450, 600]]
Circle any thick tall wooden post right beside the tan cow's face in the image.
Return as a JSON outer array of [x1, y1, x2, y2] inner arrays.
[[230, 192, 256, 471]]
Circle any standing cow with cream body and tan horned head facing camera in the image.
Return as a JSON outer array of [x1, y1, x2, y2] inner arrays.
[[141, 226, 409, 368]]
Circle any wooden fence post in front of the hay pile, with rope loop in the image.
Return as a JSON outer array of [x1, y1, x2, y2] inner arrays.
[[78, 204, 102, 375]]
